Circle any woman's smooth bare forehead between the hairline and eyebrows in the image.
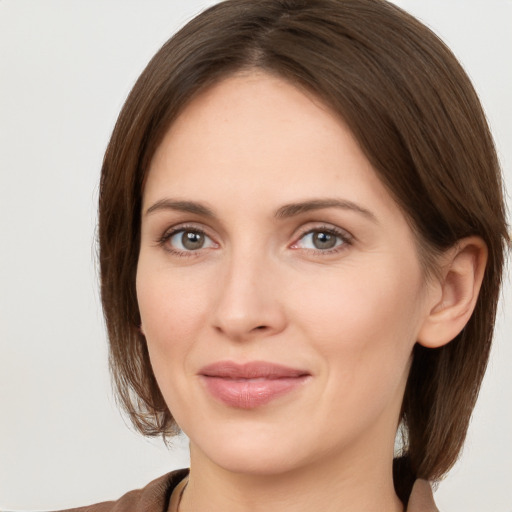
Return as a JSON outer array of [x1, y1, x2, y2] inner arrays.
[[144, 72, 404, 224]]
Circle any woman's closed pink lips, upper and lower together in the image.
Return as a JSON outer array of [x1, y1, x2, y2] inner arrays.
[[198, 361, 311, 409]]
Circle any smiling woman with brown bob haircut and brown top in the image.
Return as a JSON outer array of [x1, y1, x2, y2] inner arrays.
[[62, 0, 507, 512]]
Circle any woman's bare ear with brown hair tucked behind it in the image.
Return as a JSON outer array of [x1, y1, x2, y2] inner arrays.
[[418, 236, 488, 348]]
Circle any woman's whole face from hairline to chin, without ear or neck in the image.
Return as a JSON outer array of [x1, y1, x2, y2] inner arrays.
[[137, 72, 427, 474]]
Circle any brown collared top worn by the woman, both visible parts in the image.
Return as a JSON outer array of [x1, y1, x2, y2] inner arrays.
[[55, 469, 439, 512]]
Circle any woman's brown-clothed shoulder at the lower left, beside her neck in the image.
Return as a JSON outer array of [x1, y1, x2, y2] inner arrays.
[[52, 469, 188, 512]]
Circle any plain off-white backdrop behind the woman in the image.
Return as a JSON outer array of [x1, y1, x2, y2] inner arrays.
[[0, 0, 512, 512]]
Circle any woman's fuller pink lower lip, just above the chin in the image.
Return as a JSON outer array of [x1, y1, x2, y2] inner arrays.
[[202, 375, 308, 409]]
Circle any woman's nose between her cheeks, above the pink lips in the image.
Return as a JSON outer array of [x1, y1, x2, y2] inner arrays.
[[213, 250, 286, 341]]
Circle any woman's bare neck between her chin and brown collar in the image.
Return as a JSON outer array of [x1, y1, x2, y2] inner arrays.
[[180, 446, 403, 512]]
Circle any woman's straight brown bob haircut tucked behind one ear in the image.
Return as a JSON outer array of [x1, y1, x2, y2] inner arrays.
[[99, 0, 507, 504]]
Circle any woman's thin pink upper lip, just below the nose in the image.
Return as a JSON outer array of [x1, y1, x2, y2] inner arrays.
[[199, 361, 309, 379]]
